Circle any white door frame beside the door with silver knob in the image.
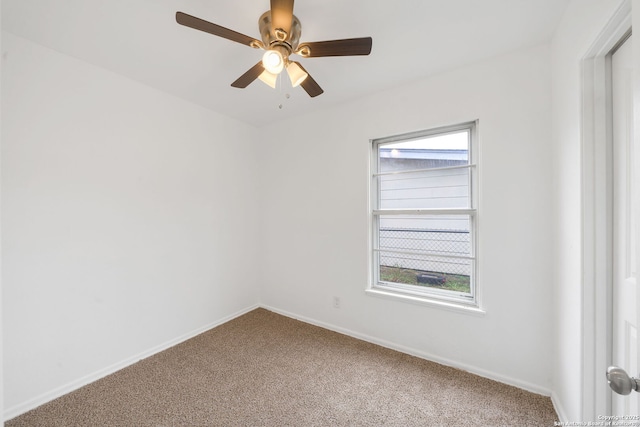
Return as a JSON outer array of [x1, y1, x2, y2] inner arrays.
[[581, 0, 635, 420]]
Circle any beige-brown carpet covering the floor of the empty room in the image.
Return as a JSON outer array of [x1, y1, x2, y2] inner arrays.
[[6, 309, 557, 427]]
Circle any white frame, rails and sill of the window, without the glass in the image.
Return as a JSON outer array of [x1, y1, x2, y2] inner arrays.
[[366, 121, 484, 314]]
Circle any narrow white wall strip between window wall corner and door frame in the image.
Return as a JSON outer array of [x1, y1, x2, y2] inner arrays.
[[551, 0, 632, 421]]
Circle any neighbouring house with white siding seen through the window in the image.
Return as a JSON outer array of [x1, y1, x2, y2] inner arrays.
[[379, 149, 472, 276]]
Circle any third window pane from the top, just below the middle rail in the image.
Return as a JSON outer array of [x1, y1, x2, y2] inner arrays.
[[378, 215, 472, 256]]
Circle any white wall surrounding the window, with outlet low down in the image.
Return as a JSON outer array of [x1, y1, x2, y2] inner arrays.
[[261, 46, 554, 394]]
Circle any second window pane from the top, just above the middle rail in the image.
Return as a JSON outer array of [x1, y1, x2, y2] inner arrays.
[[378, 168, 471, 209]]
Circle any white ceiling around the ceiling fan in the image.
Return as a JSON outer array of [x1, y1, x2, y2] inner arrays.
[[2, 0, 569, 126]]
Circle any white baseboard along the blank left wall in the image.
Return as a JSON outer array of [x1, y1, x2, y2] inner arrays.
[[3, 304, 259, 421]]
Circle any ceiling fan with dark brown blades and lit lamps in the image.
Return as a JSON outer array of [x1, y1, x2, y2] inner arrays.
[[176, 0, 373, 97]]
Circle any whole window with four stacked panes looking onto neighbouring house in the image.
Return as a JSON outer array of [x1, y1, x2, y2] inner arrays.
[[371, 123, 477, 306]]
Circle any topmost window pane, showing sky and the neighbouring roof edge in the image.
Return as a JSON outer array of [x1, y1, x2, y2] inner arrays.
[[378, 130, 469, 172]]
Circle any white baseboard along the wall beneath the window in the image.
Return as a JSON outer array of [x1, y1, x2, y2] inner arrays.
[[260, 304, 552, 396]]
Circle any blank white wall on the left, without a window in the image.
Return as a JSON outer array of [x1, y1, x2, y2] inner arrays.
[[2, 33, 259, 416]]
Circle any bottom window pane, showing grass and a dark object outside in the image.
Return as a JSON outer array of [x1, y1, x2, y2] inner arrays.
[[379, 252, 473, 293]]
